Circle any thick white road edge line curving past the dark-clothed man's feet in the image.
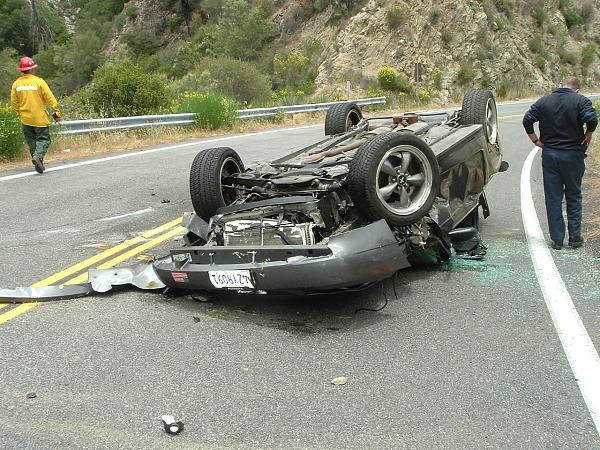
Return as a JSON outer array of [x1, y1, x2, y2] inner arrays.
[[521, 147, 600, 434]]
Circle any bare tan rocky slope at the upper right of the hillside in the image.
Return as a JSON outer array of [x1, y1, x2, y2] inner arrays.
[[274, 0, 600, 95]]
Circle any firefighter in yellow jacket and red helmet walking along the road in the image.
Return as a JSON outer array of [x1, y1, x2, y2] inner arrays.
[[10, 56, 60, 173]]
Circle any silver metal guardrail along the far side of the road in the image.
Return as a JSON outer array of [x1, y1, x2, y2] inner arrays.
[[56, 97, 385, 135]]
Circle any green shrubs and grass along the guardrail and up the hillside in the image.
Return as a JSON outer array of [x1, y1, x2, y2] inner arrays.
[[0, 0, 598, 162]]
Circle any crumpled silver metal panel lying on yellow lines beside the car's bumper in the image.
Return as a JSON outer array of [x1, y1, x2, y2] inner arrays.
[[88, 263, 165, 292]]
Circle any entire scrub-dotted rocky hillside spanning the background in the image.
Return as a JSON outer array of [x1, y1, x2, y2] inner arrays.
[[0, 0, 600, 104]]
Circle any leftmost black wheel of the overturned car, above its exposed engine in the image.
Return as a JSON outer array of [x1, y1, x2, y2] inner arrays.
[[190, 147, 244, 221]]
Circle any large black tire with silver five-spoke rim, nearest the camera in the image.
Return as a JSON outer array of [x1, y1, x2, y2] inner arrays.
[[348, 132, 440, 226]]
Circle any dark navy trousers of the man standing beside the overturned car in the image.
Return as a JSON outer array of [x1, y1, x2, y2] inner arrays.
[[542, 147, 585, 242]]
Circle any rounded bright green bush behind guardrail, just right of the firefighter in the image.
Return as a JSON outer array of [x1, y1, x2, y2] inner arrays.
[[82, 60, 171, 117]]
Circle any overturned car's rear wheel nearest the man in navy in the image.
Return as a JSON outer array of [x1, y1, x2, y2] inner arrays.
[[461, 89, 498, 145]]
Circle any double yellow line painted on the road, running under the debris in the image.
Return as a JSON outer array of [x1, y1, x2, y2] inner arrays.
[[0, 217, 186, 324]]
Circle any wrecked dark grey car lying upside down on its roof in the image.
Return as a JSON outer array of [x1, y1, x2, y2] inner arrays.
[[153, 90, 508, 293]]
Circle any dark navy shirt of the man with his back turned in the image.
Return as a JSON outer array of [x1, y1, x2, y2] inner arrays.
[[523, 88, 598, 151]]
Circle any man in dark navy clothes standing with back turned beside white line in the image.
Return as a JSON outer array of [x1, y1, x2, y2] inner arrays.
[[523, 77, 598, 250]]
